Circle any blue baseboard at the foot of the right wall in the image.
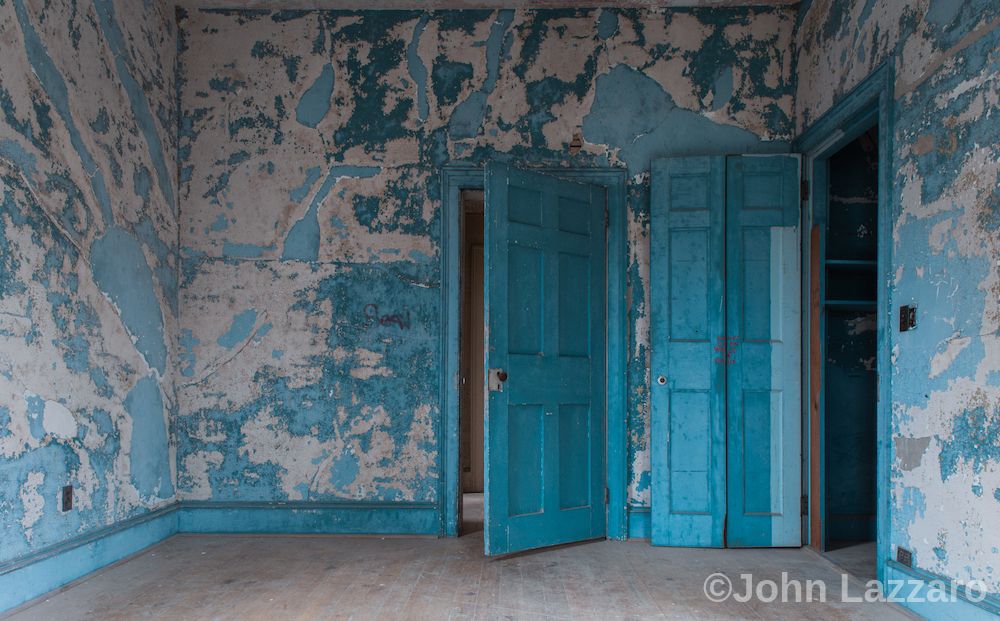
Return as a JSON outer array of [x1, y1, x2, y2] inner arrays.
[[884, 560, 1000, 621]]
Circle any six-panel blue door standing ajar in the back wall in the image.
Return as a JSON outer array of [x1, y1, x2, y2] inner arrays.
[[484, 164, 607, 555]]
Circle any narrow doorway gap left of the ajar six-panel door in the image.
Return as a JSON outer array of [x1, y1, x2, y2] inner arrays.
[[459, 190, 486, 536]]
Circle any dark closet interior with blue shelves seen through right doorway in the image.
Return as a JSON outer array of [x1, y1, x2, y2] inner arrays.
[[812, 125, 879, 580]]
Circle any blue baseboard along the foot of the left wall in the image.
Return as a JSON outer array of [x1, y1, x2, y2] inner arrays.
[[0, 504, 177, 612]]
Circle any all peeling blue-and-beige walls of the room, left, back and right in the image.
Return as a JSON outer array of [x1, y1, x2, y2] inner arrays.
[[0, 0, 1000, 604]]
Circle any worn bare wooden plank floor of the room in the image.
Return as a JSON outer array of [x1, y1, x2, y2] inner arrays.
[[10, 502, 912, 621]]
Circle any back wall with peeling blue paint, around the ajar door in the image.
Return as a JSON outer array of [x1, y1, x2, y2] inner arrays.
[[176, 7, 795, 508]]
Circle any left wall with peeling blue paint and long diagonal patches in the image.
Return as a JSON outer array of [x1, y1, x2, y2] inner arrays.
[[0, 0, 179, 562]]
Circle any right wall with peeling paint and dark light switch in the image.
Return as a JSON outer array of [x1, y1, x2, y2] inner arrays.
[[796, 0, 1000, 594]]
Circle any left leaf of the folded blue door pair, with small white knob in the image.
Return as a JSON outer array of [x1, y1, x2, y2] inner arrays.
[[649, 157, 726, 547]]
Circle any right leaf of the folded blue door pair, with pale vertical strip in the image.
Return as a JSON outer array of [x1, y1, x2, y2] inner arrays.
[[726, 156, 801, 547]]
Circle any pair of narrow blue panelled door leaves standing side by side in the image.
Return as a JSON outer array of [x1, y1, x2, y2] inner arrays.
[[650, 155, 801, 547]]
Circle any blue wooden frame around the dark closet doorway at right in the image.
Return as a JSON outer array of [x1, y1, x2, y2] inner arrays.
[[792, 59, 895, 580]]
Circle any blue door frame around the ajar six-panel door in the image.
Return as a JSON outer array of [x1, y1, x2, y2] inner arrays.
[[438, 163, 628, 539]]
